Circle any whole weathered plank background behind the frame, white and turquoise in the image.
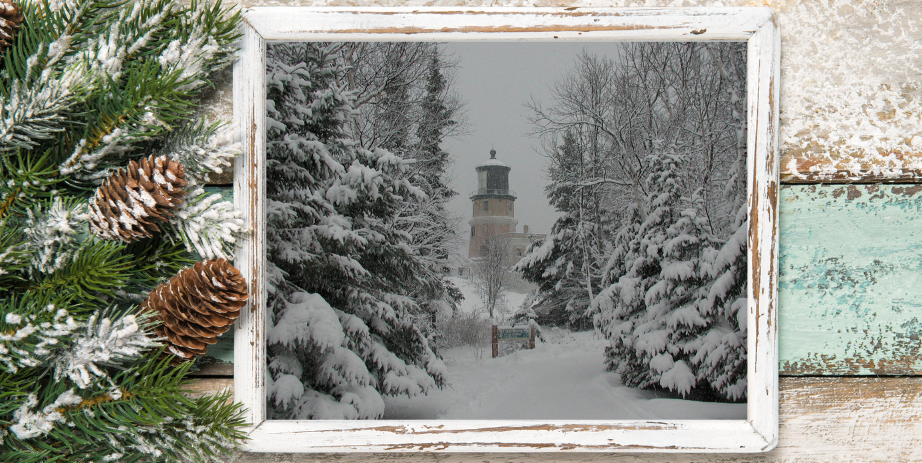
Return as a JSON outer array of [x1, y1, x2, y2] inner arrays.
[[183, 0, 922, 463]]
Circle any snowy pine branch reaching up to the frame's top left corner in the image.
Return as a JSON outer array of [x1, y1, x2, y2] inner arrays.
[[61, 0, 239, 181]]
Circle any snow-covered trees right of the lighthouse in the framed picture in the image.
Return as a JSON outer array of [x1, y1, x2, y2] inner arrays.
[[518, 43, 748, 401]]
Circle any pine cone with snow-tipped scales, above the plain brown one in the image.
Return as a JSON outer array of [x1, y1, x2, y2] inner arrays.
[[89, 156, 188, 242]]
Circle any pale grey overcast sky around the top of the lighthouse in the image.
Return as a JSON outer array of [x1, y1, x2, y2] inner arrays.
[[443, 42, 618, 244]]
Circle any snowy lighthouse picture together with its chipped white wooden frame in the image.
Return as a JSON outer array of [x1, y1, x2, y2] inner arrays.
[[234, 7, 779, 452]]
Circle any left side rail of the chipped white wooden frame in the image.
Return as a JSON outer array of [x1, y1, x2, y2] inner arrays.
[[234, 23, 266, 430]]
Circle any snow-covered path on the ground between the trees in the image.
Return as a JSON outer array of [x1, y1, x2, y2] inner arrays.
[[384, 333, 746, 420]]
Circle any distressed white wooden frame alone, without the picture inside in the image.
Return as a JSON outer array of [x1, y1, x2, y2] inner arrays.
[[234, 7, 780, 452]]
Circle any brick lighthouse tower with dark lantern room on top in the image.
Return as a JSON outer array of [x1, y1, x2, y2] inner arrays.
[[468, 150, 518, 259]]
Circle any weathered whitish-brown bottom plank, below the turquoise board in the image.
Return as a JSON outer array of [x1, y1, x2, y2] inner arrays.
[[198, 377, 922, 463]]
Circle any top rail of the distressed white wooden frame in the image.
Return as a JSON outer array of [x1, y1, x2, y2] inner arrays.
[[246, 7, 772, 41]]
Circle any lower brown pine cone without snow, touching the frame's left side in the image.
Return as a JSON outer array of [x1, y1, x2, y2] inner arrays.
[[141, 259, 249, 363]]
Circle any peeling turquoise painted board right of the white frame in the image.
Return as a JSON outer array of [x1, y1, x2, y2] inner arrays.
[[778, 185, 922, 375]]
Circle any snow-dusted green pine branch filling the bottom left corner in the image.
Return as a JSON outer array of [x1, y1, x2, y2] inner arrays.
[[0, 359, 246, 463]]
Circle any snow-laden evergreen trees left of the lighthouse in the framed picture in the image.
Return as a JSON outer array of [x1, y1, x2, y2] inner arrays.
[[266, 43, 453, 419]]
